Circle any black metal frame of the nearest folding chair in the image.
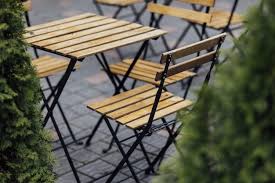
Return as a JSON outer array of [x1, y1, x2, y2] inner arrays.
[[101, 33, 229, 183]]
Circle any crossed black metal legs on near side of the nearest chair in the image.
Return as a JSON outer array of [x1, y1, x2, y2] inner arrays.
[[104, 117, 142, 183]]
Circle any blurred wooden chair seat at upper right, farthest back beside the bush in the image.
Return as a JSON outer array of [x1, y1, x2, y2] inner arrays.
[[207, 10, 243, 29]]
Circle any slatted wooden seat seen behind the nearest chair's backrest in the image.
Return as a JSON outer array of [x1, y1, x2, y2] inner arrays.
[[110, 59, 196, 85]]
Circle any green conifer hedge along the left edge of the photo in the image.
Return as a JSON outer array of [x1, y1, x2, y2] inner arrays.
[[0, 0, 54, 183]]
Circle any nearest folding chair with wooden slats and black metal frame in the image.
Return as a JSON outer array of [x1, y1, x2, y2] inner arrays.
[[88, 33, 226, 183]]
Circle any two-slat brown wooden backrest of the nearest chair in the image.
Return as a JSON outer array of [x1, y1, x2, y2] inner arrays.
[[155, 33, 226, 81]]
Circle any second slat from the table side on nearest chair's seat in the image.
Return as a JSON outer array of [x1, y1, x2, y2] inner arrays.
[[96, 89, 158, 114]]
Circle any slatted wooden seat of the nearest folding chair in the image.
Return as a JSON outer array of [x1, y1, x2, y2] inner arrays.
[[87, 84, 192, 129]]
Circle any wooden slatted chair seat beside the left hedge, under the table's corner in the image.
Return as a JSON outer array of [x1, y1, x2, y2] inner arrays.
[[32, 56, 80, 78]]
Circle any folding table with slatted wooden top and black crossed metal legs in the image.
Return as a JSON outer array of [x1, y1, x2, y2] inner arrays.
[[24, 13, 167, 182]]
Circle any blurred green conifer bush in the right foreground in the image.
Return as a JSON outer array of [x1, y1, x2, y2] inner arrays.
[[155, 0, 275, 183]]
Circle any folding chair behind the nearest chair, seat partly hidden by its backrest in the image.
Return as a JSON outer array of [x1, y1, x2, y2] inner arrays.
[[86, 0, 211, 149]]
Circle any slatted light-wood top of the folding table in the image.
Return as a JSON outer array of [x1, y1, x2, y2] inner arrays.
[[24, 13, 167, 59]]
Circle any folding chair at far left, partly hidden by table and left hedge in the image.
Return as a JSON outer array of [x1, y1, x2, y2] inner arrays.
[[23, 0, 82, 145]]
